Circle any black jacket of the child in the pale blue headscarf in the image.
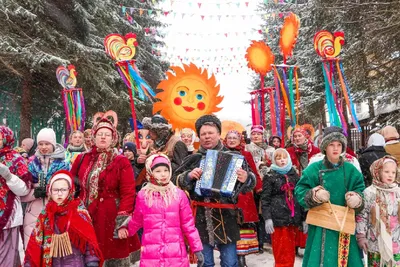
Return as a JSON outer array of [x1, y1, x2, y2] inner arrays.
[[261, 168, 305, 227]]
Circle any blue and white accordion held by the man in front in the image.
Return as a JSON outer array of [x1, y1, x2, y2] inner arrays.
[[195, 150, 244, 198]]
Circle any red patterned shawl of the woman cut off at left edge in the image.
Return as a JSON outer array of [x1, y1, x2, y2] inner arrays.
[[0, 126, 31, 233]]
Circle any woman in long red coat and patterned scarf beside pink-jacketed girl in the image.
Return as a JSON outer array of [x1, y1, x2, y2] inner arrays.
[[71, 118, 140, 267]]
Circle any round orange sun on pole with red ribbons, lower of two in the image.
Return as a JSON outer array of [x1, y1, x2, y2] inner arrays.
[[245, 41, 276, 134]]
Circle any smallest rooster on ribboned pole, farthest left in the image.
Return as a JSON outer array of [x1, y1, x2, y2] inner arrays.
[[56, 65, 86, 144]]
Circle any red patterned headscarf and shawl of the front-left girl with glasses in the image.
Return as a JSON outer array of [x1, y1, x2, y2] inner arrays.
[[25, 170, 103, 267]]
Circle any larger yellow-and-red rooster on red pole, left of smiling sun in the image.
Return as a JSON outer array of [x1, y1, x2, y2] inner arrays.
[[104, 33, 155, 147]]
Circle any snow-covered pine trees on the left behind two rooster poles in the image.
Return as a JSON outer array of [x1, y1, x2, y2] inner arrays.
[[0, 0, 168, 138]]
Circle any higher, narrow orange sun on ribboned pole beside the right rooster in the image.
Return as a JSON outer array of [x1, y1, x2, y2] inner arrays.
[[273, 13, 300, 139]]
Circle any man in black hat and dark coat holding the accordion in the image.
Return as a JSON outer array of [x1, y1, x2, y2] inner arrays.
[[174, 115, 255, 267]]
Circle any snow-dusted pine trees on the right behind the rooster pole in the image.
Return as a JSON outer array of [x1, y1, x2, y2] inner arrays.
[[253, 0, 400, 131]]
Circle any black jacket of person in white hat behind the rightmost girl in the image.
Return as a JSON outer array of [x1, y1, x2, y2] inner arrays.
[[358, 146, 389, 187]]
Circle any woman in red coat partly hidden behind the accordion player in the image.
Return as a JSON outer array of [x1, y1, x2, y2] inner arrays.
[[224, 130, 262, 267]]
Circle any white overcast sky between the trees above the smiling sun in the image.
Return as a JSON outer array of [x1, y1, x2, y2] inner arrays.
[[159, 0, 261, 129]]
